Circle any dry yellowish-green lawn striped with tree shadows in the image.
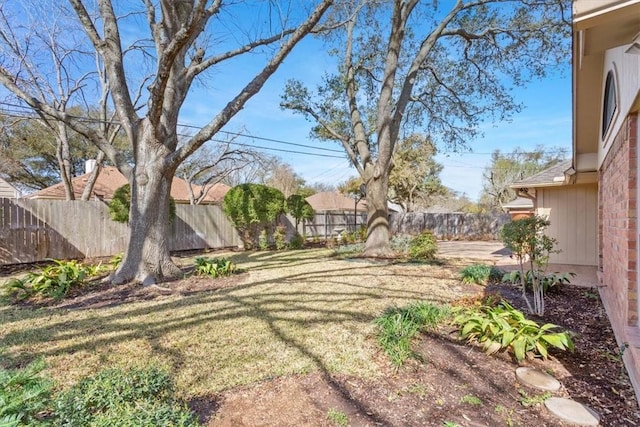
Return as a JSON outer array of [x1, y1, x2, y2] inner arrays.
[[0, 249, 470, 397]]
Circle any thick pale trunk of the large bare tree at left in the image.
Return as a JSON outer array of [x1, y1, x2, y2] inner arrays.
[[111, 149, 182, 285]]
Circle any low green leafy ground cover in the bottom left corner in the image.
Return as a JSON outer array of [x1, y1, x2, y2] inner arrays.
[[0, 359, 199, 427]]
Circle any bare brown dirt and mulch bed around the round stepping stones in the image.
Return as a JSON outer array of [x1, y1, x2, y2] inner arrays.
[[192, 285, 640, 427]]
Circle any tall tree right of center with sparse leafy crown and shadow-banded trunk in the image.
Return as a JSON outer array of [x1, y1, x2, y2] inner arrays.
[[281, 0, 571, 256]]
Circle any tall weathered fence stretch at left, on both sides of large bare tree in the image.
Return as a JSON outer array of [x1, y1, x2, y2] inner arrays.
[[0, 199, 241, 264]]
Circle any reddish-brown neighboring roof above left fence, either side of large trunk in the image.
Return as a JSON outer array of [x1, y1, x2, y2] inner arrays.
[[29, 166, 229, 204]]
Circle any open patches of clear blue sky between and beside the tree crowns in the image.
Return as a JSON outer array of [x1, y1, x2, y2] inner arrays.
[[181, 31, 571, 200]]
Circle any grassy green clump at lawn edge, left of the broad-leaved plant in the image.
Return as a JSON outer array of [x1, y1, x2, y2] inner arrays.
[[375, 302, 449, 367]]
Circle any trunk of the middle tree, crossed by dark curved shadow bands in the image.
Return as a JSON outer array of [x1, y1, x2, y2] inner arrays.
[[364, 173, 391, 257]]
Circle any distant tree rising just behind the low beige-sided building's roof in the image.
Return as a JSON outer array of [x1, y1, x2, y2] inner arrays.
[[480, 145, 568, 211]]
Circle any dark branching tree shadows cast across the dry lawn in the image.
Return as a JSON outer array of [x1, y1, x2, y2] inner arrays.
[[0, 249, 484, 424]]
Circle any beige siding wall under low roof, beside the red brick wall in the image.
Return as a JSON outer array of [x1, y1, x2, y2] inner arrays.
[[537, 185, 598, 265]]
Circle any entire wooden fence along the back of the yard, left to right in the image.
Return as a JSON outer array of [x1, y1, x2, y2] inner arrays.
[[0, 198, 509, 264]]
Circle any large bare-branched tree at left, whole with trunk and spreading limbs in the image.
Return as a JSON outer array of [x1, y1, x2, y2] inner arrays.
[[0, 0, 332, 284]]
